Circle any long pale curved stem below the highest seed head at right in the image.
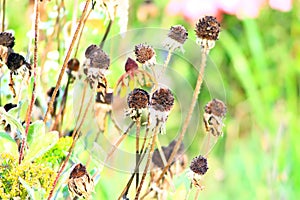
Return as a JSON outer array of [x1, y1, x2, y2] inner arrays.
[[156, 49, 209, 184]]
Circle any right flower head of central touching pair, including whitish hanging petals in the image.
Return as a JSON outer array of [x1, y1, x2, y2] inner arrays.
[[149, 88, 174, 134]]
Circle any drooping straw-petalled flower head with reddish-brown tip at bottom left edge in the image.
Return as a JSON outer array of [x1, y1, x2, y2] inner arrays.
[[68, 163, 94, 199]]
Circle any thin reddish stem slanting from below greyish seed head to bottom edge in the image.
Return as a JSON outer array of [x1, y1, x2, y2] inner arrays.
[[48, 84, 93, 200]]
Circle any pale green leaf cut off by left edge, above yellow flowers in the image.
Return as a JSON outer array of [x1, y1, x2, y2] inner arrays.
[[0, 132, 19, 157]]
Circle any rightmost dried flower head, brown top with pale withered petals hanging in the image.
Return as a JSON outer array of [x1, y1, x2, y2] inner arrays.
[[203, 99, 227, 137]]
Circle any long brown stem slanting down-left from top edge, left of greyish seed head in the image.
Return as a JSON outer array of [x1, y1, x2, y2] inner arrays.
[[44, 0, 91, 122]]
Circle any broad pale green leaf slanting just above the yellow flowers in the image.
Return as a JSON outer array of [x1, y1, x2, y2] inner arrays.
[[24, 131, 59, 161]]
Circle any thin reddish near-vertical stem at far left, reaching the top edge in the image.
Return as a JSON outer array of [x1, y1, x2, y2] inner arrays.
[[19, 0, 40, 164]]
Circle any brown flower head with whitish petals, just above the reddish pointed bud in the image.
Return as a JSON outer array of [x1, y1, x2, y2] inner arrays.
[[134, 44, 156, 66]]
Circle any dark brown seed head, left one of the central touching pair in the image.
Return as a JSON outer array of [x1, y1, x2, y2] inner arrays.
[[127, 88, 149, 109]]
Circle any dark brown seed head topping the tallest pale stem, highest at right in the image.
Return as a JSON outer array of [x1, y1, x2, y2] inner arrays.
[[195, 16, 220, 40]]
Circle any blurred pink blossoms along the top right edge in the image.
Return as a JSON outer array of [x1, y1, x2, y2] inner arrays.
[[167, 0, 292, 22]]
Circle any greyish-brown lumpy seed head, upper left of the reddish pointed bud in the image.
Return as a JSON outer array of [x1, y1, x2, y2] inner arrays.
[[85, 44, 110, 70]]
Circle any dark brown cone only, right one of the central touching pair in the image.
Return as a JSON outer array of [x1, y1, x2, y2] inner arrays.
[[151, 88, 174, 112]]
